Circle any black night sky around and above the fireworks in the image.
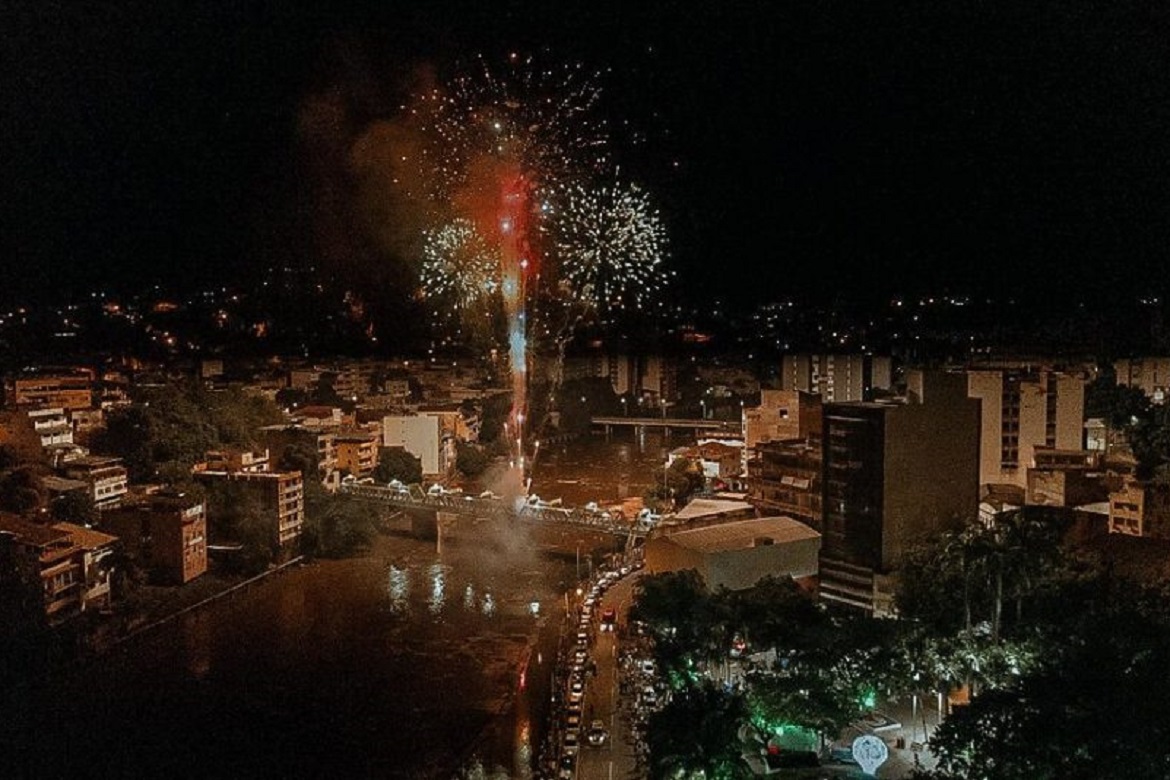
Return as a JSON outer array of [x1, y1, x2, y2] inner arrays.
[[0, 0, 1170, 311]]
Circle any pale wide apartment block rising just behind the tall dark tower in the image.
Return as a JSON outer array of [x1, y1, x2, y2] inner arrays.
[[780, 354, 893, 403]]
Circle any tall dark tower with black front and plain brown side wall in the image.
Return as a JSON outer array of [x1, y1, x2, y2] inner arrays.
[[820, 371, 979, 615]]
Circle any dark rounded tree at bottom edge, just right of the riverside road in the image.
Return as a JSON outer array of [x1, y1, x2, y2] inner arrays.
[[646, 683, 750, 780]]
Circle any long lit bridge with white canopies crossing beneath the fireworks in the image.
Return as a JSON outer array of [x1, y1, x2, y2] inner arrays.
[[340, 483, 661, 537]]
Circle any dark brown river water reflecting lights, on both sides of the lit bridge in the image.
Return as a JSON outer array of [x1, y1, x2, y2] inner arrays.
[[0, 439, 678, 779]]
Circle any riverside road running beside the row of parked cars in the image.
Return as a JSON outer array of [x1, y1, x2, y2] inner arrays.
[[577, 572, 644, 780]]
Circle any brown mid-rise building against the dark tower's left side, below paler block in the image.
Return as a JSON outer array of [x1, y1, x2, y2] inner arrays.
[[748, 439, 823, 531]]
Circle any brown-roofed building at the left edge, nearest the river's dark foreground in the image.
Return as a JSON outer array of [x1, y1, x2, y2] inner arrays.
[[0, 515, 118, 623]]
